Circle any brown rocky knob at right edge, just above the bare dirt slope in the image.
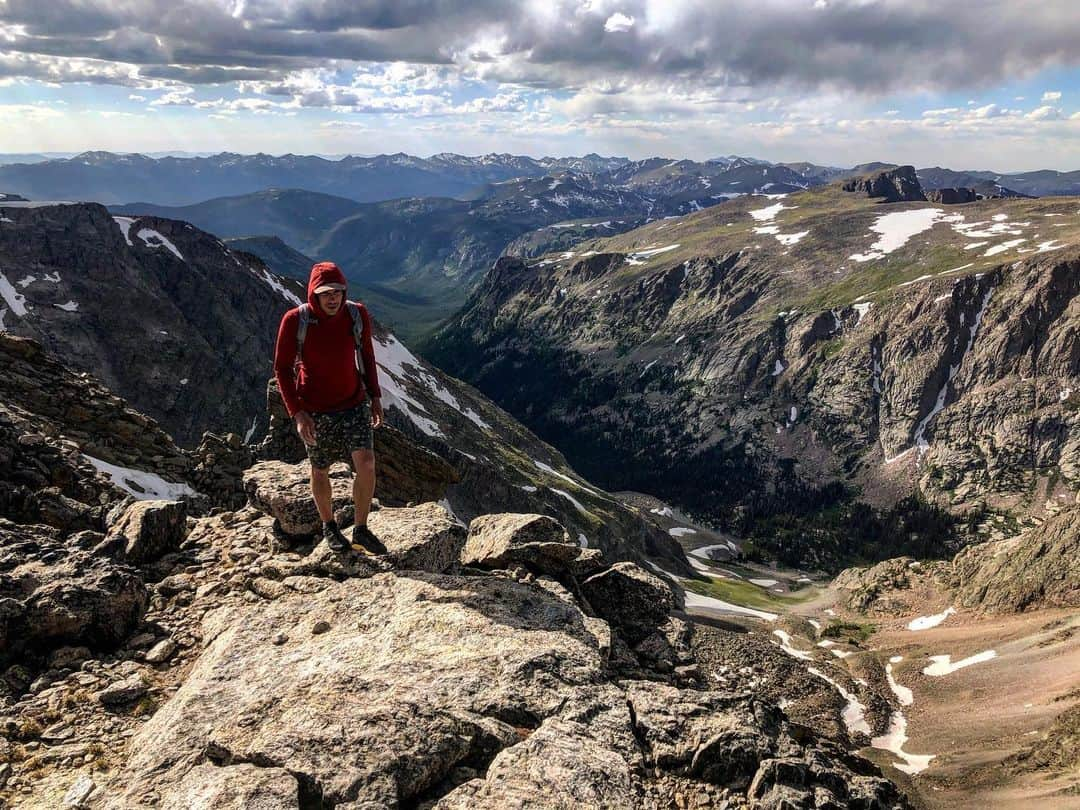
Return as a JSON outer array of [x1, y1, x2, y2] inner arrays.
[[950, 508, 1080, 612]]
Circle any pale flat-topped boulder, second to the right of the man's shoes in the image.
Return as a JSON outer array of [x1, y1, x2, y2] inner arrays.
[[461, 514, 581, 576]]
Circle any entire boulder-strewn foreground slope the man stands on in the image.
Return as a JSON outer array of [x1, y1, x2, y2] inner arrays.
[[0, 337, 909, 810]]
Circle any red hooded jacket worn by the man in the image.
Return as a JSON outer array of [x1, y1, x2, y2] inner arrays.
[[273, 261, 382, 416]]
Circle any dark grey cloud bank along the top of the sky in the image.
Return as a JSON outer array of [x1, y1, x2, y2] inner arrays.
[[0, 0, 1080, 93]]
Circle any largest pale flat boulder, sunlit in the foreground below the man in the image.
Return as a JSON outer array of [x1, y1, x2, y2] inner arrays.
[[103, 572, 603, 808]]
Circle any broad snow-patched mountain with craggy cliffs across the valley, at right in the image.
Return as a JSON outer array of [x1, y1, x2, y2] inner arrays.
[[424, 167, 1080, 566]]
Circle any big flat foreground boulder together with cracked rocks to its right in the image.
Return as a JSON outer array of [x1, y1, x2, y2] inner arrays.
[[101, 533, 906, 810]]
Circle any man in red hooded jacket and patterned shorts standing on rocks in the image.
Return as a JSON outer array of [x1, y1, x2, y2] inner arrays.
[[273, 261, 387, 554]]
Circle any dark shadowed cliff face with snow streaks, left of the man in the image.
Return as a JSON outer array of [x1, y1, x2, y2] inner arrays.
[[0, 203, 303, 447]]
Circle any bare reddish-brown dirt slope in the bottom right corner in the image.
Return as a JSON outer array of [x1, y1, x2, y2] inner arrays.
[[864, 610, 1080, 810]]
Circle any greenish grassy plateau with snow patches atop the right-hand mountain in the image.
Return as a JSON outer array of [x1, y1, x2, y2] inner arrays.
[[524, 186, 1080, 319]]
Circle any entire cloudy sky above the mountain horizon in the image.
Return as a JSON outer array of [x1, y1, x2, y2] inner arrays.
[[0, 0, 1080, 172]]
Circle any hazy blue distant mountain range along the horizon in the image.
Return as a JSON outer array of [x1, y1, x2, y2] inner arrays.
[[0, 151, 1080, 205]]
